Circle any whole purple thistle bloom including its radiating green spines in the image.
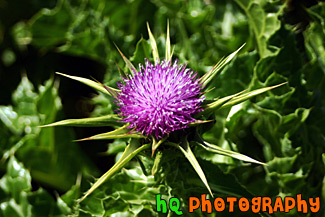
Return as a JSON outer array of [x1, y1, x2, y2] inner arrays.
[[46, 22, 282, 201]]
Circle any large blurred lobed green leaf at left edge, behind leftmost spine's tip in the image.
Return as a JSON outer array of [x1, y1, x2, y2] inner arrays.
[[0, 76, 96, 192]]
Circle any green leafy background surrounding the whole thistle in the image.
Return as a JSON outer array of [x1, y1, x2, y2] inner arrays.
[[0, 0, 325, 217]]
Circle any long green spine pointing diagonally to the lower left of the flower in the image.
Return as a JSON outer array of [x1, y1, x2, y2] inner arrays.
[[78, 140, 151, 203]]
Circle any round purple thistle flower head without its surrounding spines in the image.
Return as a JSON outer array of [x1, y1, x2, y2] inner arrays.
[[117, 60, 204, 139]]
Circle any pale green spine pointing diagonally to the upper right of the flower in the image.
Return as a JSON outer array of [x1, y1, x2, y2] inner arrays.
[[199, 44, 245, 86]]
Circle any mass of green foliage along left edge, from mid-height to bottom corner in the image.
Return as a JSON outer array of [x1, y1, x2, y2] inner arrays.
[[0, 76, 93, 216]]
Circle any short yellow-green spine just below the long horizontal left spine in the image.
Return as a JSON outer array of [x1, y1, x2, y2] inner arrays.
[[76, 124, 145, 141]]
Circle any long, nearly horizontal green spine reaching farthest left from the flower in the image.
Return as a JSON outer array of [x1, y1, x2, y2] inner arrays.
[[41, 115, 121, 127]]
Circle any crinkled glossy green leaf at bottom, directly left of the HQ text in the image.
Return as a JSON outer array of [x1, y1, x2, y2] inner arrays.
[[77, 167, 160, 217]]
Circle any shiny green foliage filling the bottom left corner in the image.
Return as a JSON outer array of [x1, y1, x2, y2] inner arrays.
[[0, 157, 70, 217]]
